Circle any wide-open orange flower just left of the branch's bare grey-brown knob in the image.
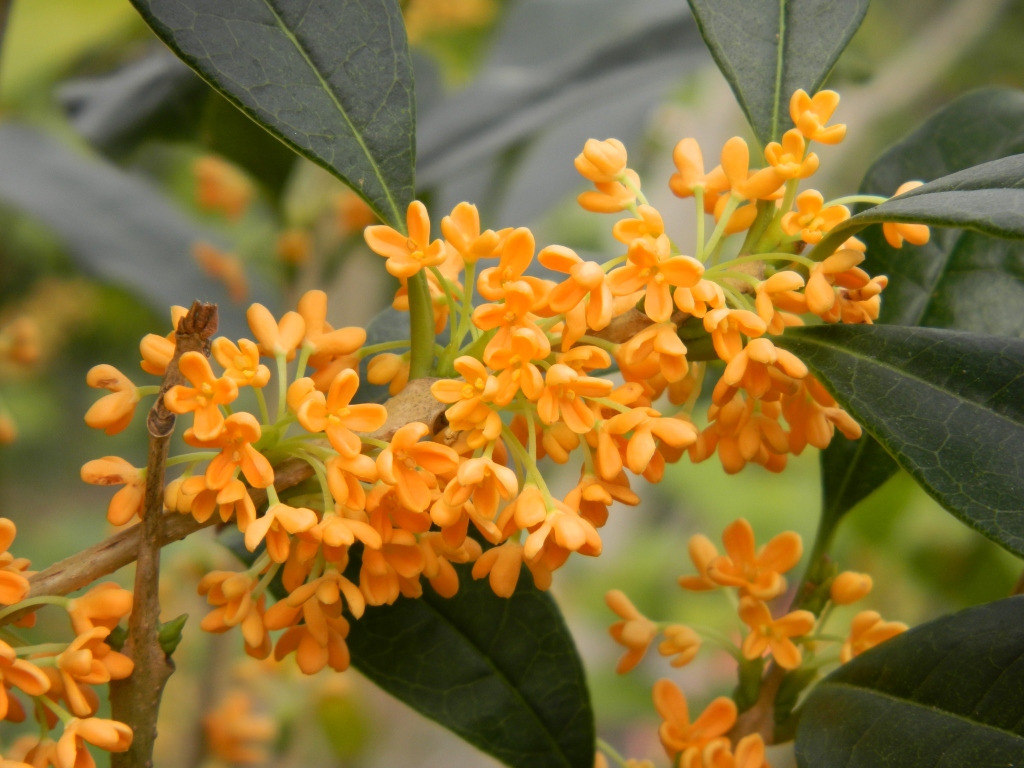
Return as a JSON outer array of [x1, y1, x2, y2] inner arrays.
[[297, 371, 387, 458]]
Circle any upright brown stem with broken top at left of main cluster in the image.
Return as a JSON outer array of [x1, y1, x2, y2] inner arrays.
[[111, 301, 217, 768]]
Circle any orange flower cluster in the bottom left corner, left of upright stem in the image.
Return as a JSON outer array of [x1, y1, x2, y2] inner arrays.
[[0, 518, 133, 768]]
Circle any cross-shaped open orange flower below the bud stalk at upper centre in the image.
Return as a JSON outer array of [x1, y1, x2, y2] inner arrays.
[[607, 236, 703, 323]]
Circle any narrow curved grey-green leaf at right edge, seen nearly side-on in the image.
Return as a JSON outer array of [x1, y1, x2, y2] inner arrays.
[[810, 155, 1024, 260]]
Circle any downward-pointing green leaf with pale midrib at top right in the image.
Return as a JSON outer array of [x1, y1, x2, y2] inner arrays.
[[688, 0, 868, 144]]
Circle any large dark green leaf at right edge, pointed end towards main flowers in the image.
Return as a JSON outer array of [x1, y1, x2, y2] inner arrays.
[[776, 326, 1024, 554]]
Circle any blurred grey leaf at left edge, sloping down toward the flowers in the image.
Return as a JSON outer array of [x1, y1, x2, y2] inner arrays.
[[0, 122, 265, 333]]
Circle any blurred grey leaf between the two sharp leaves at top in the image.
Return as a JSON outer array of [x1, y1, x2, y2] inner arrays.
[[417, 0, 703, 194]]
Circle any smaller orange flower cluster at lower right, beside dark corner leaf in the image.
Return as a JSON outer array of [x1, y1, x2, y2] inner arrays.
[[605, 518, 906, 768]]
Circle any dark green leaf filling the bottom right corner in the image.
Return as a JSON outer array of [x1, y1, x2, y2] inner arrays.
[[797, 597, 1024, 768]]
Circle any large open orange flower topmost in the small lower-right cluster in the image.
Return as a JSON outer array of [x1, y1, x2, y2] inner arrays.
[[708, 517, 804, 600]]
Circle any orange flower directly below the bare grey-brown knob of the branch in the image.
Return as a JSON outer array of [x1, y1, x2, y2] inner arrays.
[[377, 422, 459, 512]]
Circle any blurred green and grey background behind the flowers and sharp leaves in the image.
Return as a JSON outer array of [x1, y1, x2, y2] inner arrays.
[[0, 0, 1024, 768]]
